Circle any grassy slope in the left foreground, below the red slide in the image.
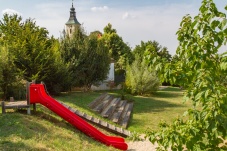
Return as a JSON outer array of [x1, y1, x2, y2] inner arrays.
[[0, 111, 116, 151]]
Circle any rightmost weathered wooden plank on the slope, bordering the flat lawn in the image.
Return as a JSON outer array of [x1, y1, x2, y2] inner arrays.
[[120, 103, 133, 128]]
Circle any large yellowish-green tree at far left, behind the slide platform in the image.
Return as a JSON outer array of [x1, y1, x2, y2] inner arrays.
[[0, 14, 67, 93]]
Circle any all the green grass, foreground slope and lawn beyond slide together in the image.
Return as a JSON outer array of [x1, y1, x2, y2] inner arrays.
[[0, 88, 190, 151]]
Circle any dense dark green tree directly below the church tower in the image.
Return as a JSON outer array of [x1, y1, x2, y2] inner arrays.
[[61, 28, 110, 91]]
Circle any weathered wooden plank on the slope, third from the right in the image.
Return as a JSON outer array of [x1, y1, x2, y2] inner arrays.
[[101, 98, 121, 118]]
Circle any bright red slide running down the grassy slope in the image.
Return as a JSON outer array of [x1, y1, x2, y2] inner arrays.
[[29, 84, 128, 150]]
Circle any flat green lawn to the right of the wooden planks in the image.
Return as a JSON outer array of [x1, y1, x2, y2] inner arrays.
[[128, 88, 191, 133]]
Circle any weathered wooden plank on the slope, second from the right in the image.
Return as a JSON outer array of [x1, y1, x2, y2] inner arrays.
[[109, 100, 127, 123]]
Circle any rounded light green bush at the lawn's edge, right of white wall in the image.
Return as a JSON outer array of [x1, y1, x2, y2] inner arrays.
[[125, 56, 160, 95]]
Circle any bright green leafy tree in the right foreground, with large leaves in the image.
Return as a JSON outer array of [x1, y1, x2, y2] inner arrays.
[[147, 0, 227, 150]]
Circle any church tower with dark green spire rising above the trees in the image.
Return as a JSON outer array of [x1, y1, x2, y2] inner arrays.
[[65, 1, 81, 37]]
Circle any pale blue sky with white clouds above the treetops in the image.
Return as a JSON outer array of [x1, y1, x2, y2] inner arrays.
[[0, 0, 227, 55]]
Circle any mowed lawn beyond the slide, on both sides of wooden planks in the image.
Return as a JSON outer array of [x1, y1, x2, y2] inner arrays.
[[56, 87, 188, 133]]
